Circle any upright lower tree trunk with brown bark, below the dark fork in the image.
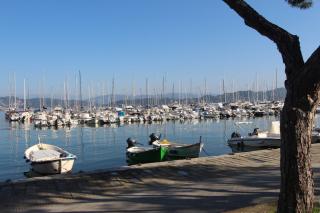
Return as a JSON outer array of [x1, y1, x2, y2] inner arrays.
[[278, 84, 315, 212]]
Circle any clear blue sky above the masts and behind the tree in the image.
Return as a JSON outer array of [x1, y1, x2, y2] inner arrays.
[[0, 0, 320, 96]]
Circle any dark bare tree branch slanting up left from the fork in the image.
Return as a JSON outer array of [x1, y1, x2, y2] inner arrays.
[[223, 0, 304, 76]]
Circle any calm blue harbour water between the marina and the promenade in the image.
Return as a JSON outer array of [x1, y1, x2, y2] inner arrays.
[[0, 113, 302, 181]]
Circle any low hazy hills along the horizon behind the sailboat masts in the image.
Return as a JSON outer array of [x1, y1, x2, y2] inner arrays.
[[0, 88, 286, 109]]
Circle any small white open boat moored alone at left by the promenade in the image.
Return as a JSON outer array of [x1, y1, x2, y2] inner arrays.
[[24, 143, 76, 174]]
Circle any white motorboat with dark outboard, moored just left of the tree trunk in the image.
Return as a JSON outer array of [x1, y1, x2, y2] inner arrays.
[[228, 121, 281, 147]]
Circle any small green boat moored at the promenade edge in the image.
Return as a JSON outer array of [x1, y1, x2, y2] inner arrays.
[[126, 146, 168, 165]]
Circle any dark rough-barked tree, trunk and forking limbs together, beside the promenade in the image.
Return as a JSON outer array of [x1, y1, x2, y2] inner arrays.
[[223, 0, 320, 212]]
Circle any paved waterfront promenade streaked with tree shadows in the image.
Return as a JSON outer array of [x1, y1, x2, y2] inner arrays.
[[0, 144, 320, 212]]
